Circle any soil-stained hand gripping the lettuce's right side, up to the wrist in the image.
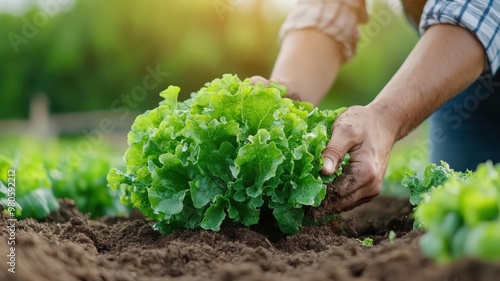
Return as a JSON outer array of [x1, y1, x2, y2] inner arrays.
[[322, 106, 396, 211]]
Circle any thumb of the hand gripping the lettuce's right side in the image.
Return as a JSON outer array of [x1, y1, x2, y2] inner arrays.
[[321, 127, 355, 176]]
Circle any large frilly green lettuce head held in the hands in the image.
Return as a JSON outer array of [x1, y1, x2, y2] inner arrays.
[[107, 75, 346, 234]]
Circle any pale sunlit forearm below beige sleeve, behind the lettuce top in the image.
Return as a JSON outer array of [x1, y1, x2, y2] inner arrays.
[[270, 28, 343, 105]]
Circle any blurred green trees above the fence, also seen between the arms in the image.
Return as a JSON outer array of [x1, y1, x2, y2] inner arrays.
[[0, 0, 417, 119]]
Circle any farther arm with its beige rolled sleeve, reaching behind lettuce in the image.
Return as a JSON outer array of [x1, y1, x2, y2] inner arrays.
[[252, 0, 367, 105]]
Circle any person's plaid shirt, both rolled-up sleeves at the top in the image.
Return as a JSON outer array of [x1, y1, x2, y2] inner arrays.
[[280, 0, 500, 73]]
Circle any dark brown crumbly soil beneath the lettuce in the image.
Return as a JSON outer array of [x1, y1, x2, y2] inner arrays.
[[0, 197, 500, 281]]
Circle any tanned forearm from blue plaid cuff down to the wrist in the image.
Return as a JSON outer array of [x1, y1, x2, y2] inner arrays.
[[368, 24, 485, 141]]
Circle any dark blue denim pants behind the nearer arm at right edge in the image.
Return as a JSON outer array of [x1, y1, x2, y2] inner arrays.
[[429, 71, 500, 171]]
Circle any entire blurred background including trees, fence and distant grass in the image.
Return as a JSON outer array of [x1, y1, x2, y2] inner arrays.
[[0, 0, 427, 196]]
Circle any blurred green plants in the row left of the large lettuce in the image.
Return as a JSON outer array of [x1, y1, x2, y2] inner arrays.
[[0, 136, 129, 219]]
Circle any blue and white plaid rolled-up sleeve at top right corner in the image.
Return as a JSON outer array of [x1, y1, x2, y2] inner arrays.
[[419, 0, 500, 74]]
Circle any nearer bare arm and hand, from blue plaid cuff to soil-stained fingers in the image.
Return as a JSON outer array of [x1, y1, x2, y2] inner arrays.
[[323, 24, 485, 210]]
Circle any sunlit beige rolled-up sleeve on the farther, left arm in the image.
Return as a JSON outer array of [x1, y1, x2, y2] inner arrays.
[[280, 0, 367, 61]]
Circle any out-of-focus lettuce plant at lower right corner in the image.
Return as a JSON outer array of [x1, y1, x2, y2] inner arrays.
[[403, 162, 500, 262]]
